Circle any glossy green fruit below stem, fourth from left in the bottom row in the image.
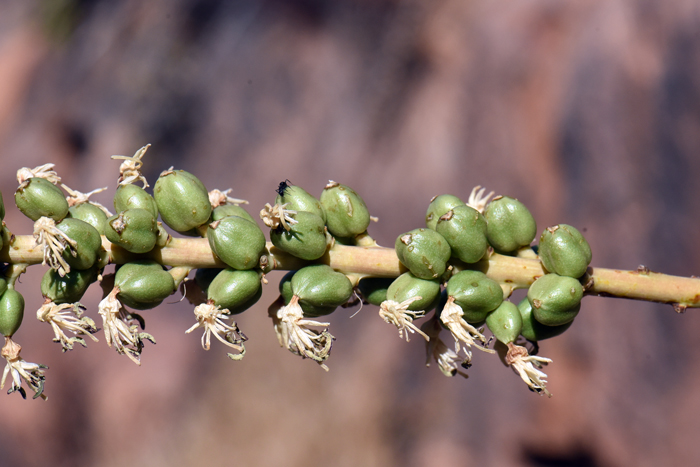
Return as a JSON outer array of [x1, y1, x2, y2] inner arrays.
[[207, 269, 262, 315]]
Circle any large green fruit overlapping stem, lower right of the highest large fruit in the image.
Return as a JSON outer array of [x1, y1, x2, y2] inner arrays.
[[207, 216, 265, 270]]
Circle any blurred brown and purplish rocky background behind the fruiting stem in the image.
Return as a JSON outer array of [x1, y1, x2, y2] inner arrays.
[[0, 0, 700, 466]]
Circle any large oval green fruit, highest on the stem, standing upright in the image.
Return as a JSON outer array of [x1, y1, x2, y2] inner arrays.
[[153, 170, 212, 232]]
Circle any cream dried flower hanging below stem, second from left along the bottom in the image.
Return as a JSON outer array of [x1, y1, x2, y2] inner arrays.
[[36, 299, 98, 352]]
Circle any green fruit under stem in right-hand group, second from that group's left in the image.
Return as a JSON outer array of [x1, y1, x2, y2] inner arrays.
[[447, 270, 503, 323]]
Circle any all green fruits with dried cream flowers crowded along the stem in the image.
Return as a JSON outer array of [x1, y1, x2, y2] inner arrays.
[[0, 146, 591, 398]]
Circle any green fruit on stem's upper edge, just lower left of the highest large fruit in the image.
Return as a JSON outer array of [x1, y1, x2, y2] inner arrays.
[[105, 209, 158, 253]]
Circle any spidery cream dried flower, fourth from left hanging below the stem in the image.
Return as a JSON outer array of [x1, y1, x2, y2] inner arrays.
[[185, 303, 248, 360]]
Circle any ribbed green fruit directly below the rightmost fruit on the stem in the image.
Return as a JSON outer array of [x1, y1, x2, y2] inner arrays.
[[527, 274, 583, 326]]
